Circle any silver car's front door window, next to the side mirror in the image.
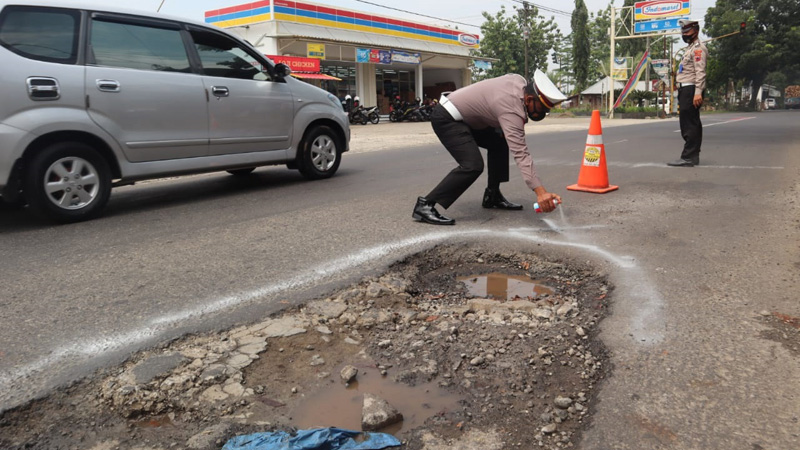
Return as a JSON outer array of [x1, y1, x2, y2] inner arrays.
[[190, 29, 273, 81]]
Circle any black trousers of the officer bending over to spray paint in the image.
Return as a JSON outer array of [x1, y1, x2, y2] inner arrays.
[[426, 105, 509, 209]]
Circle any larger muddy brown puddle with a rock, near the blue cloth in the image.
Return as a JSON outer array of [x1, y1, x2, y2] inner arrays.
[[291, 367, 461, 435]]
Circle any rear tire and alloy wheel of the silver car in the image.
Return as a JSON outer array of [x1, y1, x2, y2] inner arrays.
[[23, 142, 111, 223]]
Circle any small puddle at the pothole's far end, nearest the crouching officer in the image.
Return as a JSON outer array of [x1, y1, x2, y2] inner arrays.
[[458, 273, 555, 300]]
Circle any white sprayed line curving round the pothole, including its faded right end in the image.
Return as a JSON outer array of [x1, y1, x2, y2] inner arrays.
[[0, 225, 664, 398]]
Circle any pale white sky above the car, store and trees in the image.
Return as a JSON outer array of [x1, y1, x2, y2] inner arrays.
[[114, 0, 715, 34]]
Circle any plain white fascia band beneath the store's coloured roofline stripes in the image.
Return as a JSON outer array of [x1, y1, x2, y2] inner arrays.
[[275, 21, 472, 58]]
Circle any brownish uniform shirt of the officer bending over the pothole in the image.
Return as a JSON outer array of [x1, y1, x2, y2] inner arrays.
[[447, 74, 542, 189]]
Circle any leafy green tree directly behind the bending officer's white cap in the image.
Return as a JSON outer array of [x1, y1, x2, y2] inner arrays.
[[475, 4, 558, 78]]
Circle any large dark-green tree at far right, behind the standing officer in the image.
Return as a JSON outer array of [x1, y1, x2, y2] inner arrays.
[[705, 0, 800, 109]]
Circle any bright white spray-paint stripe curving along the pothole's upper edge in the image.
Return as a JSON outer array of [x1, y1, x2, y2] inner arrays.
[[0, 223, 660, 391]]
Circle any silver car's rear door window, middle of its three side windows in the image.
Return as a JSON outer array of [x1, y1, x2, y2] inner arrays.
[[90, 17, 191, 73]]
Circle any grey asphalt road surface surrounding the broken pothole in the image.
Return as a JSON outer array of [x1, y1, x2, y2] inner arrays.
[[0, 111, 800, 450]]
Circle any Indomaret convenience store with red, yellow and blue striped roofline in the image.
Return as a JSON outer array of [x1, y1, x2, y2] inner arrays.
[[205, 0, 484, 113]]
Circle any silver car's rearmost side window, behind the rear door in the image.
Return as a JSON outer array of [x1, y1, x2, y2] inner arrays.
[[0, 6, 81, 64]]
